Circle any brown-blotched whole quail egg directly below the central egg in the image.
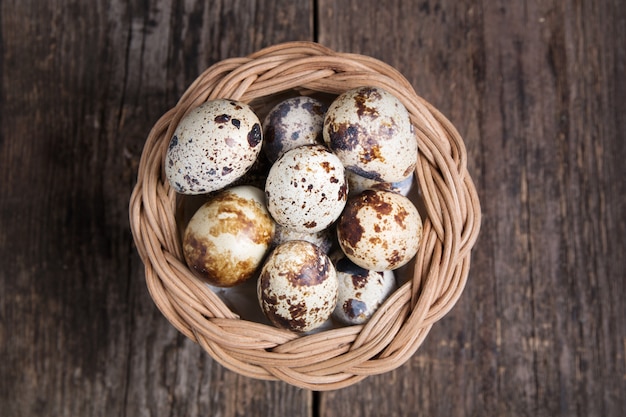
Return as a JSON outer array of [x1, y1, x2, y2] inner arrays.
[[257, 240, 338, 332]]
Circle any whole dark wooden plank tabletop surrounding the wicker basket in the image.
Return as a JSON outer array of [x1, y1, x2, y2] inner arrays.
[[0, 0, 626, 417]]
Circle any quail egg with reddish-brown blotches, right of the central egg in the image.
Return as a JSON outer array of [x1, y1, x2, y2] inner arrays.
[[337, 190, 422, 271]]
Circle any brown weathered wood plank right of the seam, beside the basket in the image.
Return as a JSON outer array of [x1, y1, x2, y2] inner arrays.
[[319, 0, 626, 416]]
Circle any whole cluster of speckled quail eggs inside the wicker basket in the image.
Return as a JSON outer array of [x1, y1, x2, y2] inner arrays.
[[164, 86, 422, 332]]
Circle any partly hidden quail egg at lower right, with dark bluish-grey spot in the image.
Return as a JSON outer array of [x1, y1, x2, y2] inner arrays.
[[333, 257, 396, 325]]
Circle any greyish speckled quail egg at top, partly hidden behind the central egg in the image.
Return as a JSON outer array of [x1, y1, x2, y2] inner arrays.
[[263, 96, 328, 162]]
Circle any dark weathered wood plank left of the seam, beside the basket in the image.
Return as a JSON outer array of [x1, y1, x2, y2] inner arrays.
[[0, 0, 313, 416]]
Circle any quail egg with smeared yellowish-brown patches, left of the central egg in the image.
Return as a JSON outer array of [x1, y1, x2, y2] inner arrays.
[[183, 185, 275, 287]]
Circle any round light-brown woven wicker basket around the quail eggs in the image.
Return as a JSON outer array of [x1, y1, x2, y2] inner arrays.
[[130, 42, 480, 390]]
